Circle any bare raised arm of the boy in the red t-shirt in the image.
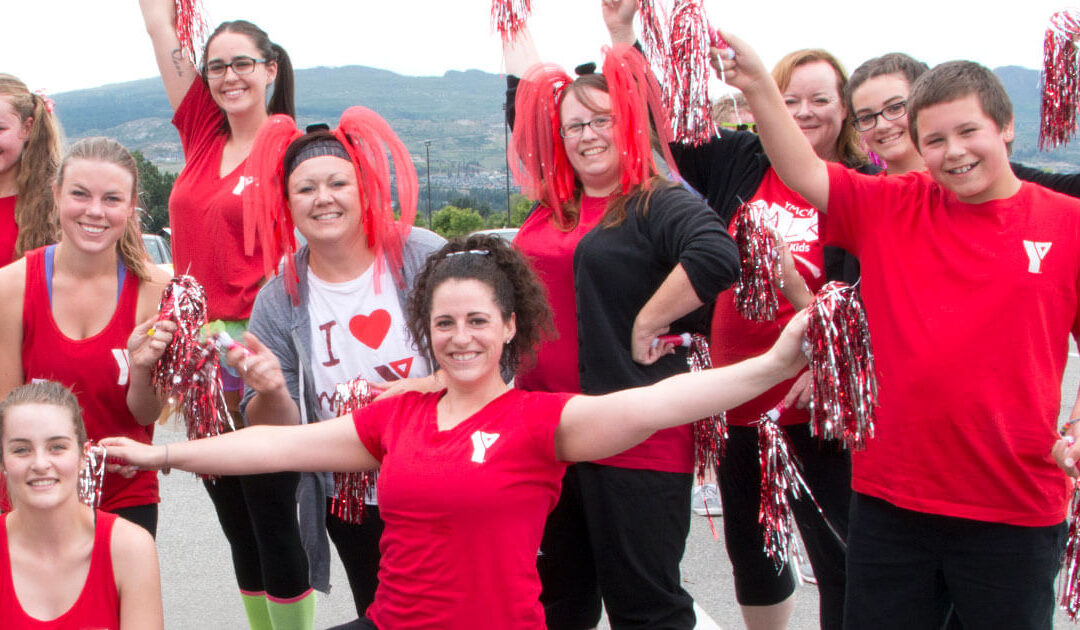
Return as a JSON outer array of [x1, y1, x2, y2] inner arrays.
[[712, 32, 828, 212]]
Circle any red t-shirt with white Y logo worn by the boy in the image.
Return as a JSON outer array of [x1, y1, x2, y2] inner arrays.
[[827, 164, 1080, 526]]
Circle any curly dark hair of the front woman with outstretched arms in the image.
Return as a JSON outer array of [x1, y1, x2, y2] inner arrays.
[[405, 236, 554, 374]]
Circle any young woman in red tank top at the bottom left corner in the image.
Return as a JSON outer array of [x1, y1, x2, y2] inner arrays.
[[0, 381, 164, 630]]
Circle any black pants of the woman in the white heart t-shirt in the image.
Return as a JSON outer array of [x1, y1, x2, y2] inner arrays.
[[326, 499, 384, 619]]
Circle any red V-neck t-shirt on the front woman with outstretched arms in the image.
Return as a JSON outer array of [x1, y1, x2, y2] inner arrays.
[[353, 389, 571, 630]]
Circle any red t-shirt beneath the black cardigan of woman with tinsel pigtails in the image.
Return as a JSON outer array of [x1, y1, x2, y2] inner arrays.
[[514, 197, 608, 393]]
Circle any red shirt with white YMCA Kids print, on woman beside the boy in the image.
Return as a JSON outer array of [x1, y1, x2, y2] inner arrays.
[[708, 167, 825, 427]]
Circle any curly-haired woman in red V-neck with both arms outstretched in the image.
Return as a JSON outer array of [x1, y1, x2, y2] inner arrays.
[[105, 237, 806, 630]]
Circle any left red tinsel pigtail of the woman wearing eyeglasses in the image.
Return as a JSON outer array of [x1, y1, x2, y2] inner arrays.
[[508, 64, 575, 227]]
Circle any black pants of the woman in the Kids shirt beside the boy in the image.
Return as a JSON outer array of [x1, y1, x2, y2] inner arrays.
[[719, 424, 851, 630]]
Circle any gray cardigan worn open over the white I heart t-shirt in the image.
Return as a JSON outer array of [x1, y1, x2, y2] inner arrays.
[[240, 227, 446, 592]]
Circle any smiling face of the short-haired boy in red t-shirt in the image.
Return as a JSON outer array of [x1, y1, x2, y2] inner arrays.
[[918, 94, 1015, 203]]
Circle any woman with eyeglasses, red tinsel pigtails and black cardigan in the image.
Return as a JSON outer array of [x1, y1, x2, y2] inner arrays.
[[505, 28, 739, 629]]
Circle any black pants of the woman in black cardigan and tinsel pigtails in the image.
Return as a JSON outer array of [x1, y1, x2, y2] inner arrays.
[[538, 464, 696, 630]]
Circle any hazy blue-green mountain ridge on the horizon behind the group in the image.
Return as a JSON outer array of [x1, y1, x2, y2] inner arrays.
[[48, 66, 1080, 177]]
